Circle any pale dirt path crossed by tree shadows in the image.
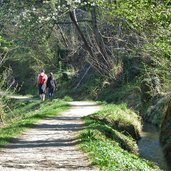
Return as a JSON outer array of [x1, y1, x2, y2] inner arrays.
[[0, 102, 100, 171]]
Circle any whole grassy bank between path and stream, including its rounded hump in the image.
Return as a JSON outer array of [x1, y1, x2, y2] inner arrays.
[[80, 105, 160, 171]]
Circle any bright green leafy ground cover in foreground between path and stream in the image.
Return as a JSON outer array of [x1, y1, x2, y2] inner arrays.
[[82, 134, 160, 171]]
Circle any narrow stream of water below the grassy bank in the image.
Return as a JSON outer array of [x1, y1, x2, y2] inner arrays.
[[138, 123, 171, 171]]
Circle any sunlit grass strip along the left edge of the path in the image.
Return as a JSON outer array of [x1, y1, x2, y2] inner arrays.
[[0, 100, 69, 146]]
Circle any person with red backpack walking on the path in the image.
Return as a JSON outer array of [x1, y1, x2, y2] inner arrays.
[[37, 70, 48, 101]]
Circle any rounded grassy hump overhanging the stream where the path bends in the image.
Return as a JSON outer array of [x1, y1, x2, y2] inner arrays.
[[91, 104, 142, 138]]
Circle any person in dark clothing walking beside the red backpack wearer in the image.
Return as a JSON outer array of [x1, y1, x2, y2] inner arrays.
[[46, 72, 57, 98]]
